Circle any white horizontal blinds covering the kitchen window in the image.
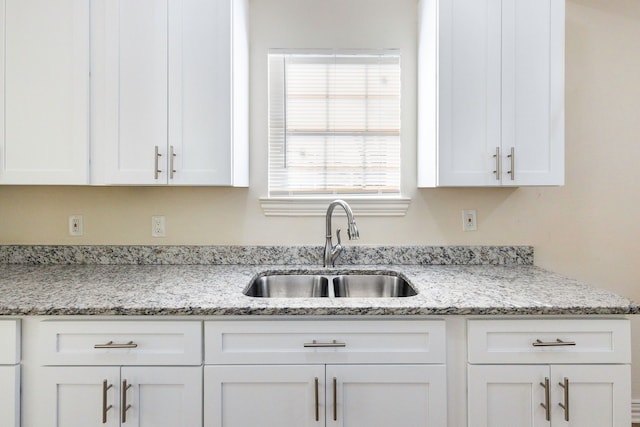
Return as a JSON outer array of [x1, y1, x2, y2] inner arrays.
[[269, 51, 400, 197]]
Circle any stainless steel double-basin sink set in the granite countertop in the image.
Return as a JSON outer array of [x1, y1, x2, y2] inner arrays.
[[243, 271, 418, 298]]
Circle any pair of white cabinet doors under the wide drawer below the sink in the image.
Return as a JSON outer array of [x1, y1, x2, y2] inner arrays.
[[204, 365, 447, 427]]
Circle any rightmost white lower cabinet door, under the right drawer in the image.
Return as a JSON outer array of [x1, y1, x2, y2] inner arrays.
[[551, 365, 631, 427]]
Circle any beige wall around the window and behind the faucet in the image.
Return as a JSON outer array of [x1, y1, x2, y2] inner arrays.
[[0, 0, 640, 397]]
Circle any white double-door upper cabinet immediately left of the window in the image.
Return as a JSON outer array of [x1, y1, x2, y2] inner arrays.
[[91, 0, 248, 186]]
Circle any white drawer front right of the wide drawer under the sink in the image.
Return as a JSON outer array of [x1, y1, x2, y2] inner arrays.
[[468, 319, 631, 364]]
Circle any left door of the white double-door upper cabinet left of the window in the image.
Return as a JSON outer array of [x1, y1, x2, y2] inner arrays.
[[92, 0, 168, 184]]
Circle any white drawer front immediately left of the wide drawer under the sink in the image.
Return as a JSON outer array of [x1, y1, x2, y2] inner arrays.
[[39, 321, 202, 365]]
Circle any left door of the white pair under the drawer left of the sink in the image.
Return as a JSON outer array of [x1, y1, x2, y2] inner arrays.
[[39, 367, 120, 427]]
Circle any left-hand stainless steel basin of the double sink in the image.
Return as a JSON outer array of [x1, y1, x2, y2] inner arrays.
[[243, 274, 329, 298]]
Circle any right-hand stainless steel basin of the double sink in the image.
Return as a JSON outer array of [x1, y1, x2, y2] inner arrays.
[[333, 274, 417, 298]]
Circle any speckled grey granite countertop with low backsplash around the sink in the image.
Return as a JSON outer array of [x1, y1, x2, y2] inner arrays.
[[0, 246, 640, 316]]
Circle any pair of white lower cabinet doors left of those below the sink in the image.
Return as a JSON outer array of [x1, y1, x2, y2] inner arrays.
[[41, 366, 202, 427]]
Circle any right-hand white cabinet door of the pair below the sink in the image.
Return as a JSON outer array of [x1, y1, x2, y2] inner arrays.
[[326, 365, 447, 427]]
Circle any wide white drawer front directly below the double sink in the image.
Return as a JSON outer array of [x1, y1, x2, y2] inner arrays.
[[205, 320, 446, 364]]
